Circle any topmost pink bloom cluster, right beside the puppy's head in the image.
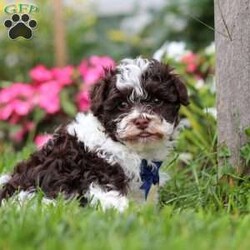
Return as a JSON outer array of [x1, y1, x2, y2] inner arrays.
[[78, 56, 115, 85]]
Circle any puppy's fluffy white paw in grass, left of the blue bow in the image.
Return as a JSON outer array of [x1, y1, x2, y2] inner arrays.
[[86, 183, 129, 212]]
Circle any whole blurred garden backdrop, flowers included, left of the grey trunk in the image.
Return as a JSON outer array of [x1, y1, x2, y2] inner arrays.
[[0, 0, 216, 168]]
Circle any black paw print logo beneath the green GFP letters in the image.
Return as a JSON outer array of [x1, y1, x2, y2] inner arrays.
[[4, 14, 37, 39]]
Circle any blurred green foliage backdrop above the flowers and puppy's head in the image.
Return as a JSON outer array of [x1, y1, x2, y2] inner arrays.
[[0, 0, 214, 81]]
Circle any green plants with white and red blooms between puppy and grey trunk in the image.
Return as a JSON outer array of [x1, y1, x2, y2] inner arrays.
[[155, 42, 216, 165]]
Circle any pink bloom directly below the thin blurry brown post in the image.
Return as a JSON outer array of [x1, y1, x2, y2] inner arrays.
[[51, 65, 74, 86]]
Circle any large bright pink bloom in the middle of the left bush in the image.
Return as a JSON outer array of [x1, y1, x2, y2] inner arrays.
[[34, 81, 61, 114]]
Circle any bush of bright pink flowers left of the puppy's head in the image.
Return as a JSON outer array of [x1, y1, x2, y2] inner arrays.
[[0, 56, 115, 146]]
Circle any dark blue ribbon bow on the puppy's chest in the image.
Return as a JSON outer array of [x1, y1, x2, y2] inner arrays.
[[140, 159, 162, 200]]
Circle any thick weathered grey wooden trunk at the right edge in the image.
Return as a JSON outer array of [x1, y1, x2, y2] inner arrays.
[[214, 0, 250, 171]]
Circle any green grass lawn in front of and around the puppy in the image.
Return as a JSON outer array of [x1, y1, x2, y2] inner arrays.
[[0, 146, 250, 250]]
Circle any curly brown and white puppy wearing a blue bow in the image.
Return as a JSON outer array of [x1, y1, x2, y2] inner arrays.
[[0, 57, 188, 211]]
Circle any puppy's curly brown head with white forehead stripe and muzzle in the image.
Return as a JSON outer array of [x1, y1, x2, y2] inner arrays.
[[91, 58, 188, 148]]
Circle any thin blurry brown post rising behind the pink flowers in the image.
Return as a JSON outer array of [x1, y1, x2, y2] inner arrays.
[[53, 0, 67, 67]]
